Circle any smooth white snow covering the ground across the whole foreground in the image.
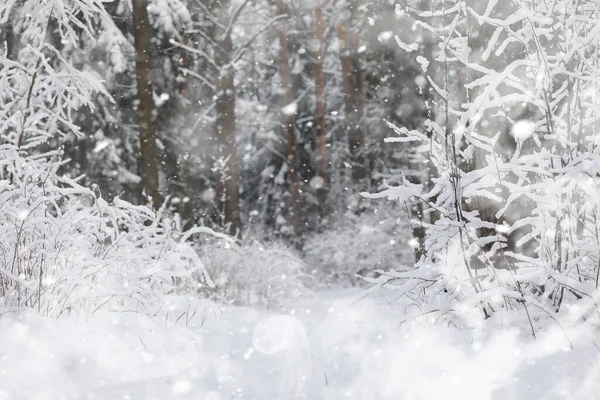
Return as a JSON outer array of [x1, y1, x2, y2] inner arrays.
[[0, 289, 600, 400]]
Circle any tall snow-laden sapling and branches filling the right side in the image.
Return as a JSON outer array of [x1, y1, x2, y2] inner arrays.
[[367, 0, 600, 332]]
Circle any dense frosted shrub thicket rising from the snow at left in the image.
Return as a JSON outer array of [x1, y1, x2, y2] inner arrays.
[[0, 145, 220, 315]]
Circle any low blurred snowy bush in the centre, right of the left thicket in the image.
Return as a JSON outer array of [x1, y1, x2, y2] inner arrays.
[[198, 240, 311, 307]]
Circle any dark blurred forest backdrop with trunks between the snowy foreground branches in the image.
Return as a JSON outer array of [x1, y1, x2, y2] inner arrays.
[[0, 0, 432, 247]]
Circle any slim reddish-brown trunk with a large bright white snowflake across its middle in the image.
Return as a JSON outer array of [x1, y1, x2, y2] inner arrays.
[[275, 0, 302, 235]]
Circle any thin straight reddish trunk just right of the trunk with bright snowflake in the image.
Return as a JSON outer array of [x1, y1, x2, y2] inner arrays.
[[315, 0, 329, 218]]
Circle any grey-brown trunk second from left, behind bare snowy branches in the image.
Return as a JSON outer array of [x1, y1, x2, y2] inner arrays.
[[213, 0, 240, 235]]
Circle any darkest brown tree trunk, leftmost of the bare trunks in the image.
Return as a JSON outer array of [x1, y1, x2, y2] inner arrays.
[[132, 0, 162, 208]]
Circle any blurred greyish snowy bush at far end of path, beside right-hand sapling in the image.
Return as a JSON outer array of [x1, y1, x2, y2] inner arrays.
[[303, 203, 415, 285]]
